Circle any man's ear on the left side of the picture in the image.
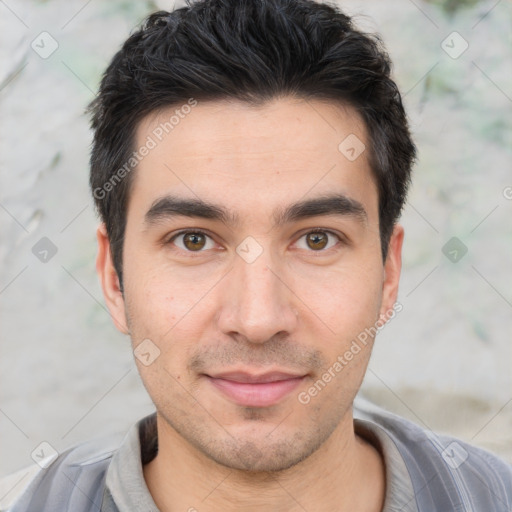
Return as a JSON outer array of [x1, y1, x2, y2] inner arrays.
[[96, 223, 130, 334]]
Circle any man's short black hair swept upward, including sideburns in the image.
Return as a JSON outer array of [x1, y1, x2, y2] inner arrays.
[[89, 0, 416, 287]]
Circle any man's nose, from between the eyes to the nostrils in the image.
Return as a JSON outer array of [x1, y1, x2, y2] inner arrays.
[[218, 245, 298, 344]]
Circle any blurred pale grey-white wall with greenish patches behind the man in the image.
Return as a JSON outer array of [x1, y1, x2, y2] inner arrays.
[[0, 0, 512, 492]]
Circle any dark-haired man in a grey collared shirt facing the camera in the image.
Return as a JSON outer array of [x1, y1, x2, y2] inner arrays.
[[5, 0, 512, 512]]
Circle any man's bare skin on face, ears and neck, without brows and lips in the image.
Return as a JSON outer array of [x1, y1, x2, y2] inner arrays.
[[97, 97, 403, 512]]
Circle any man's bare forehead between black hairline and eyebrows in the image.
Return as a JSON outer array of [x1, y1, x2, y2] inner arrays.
[[130, 98, 377, 223]]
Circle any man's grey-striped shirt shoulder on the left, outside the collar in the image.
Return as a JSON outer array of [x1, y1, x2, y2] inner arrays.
[[0, 435, 122, 512]]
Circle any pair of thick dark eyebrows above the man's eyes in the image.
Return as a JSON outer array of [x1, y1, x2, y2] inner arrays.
[[144, 194, 368, 228]]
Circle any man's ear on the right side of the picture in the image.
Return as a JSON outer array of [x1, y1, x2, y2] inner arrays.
[[380, 224, 404, 321]]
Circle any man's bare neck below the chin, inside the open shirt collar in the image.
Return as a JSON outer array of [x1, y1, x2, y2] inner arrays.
[[143, 410, 385, 512]]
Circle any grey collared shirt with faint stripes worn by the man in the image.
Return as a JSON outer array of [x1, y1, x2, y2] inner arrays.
[[9, 400, 512, 512]]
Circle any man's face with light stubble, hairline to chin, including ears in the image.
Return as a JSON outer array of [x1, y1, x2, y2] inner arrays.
[[98, 98, 402, 470]]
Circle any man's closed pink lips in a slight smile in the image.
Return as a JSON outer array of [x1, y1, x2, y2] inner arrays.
[[205, 371, 306, 407]]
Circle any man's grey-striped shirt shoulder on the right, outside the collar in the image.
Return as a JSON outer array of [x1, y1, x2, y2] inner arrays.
[[354, 400, 512, 512]]
